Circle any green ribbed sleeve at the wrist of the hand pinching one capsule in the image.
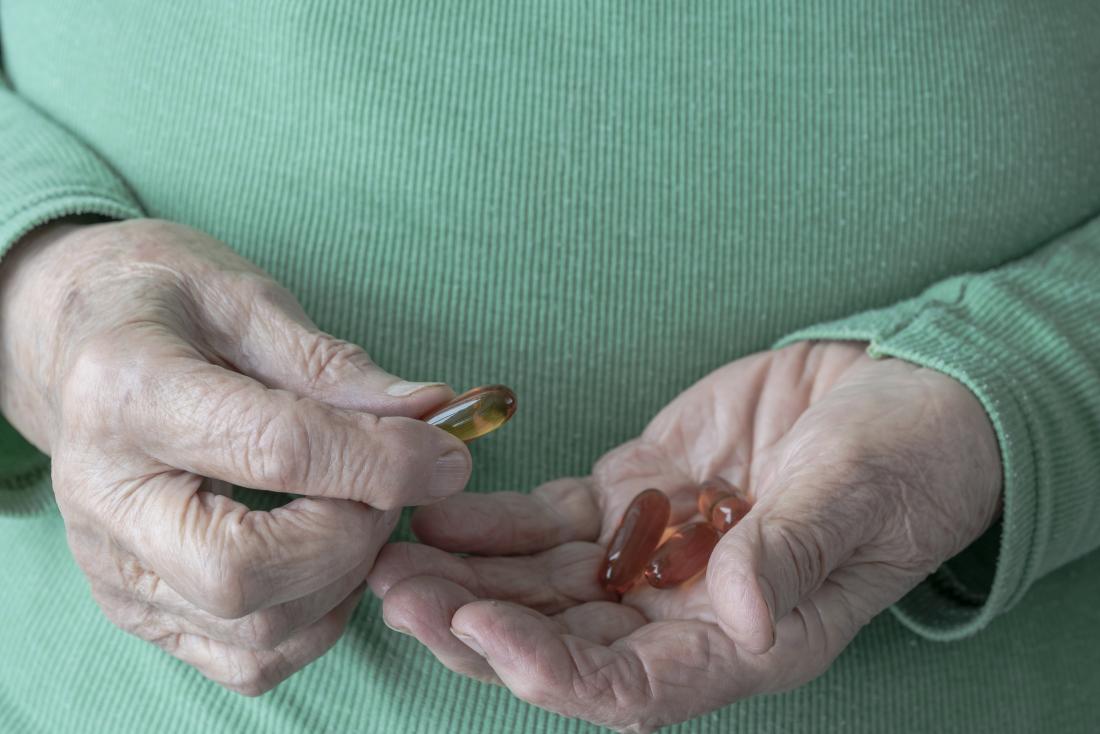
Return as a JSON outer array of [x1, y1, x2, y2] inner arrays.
[[0, 64, 142, 515]]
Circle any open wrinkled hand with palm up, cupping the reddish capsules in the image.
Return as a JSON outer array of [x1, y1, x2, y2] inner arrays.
[[370, 342, 1001, 731]]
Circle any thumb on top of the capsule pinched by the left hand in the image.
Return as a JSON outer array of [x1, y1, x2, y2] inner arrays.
[[216, 292, 454, 418]]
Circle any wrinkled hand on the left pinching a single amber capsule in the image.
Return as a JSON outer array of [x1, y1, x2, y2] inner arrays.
[[0, 220, 470, 694]]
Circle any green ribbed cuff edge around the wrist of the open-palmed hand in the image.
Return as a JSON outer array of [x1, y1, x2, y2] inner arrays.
[[776, 288, 1051, 640]]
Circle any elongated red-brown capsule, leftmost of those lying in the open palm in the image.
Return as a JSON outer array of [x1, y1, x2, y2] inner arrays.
[[597, 490, 672, 594]]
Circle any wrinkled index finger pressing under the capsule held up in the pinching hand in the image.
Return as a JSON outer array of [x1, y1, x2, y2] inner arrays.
[[131, 357, 470, 510]]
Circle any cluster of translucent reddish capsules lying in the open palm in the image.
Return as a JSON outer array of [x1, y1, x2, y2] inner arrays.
[[597, 476, 751, 594]]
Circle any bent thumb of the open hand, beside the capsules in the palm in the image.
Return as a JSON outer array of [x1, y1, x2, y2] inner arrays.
[[706, 473, 869, 655]]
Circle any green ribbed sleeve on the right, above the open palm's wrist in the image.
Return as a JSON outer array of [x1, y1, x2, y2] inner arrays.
[[777, 212, 1100, 640]]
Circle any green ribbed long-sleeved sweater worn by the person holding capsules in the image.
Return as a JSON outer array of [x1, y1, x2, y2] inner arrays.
[[0, 0, 1100, 733]]
